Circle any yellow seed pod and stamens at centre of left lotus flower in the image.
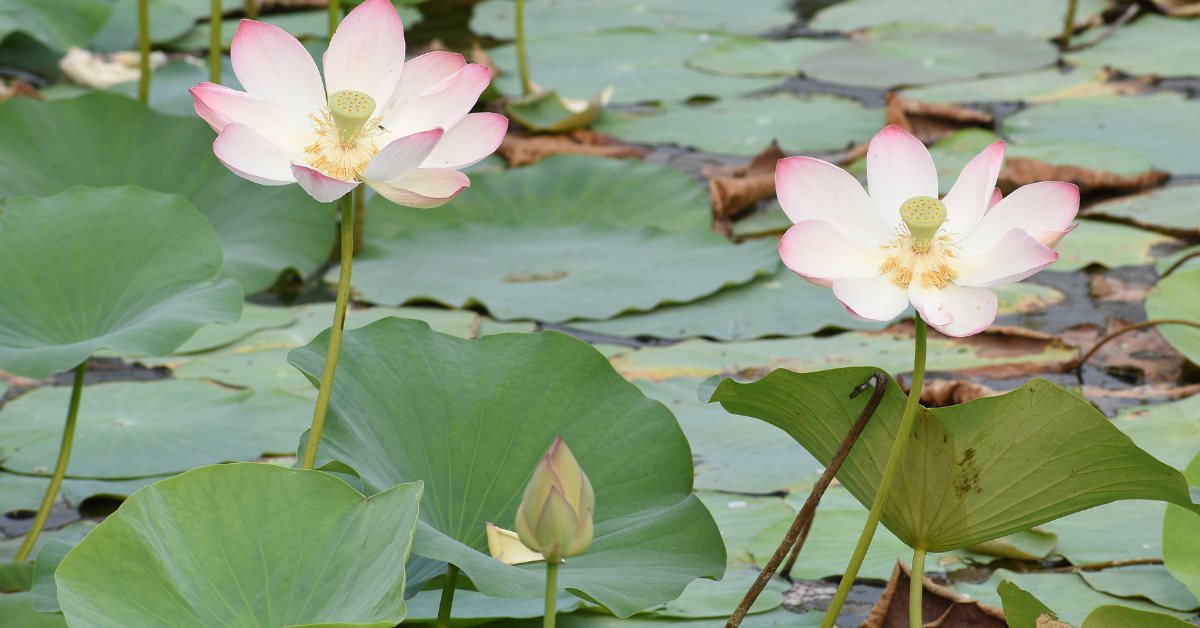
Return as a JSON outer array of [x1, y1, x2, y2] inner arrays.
[[305, 90, 383, 181]]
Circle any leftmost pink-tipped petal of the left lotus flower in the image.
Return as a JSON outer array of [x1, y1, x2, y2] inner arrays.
[[188, 83, 314, 151]]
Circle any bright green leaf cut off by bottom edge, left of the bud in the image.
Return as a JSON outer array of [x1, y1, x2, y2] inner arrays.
[[55, 463, 421, 628]]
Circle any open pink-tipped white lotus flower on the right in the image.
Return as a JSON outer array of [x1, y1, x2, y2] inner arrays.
[[775, 126, 1079, 336]]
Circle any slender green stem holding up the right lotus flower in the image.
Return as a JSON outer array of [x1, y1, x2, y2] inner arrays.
[[821, 313, 926, 628]]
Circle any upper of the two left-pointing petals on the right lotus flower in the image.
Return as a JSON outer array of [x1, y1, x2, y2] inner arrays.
[[775, 157, 890, 245]]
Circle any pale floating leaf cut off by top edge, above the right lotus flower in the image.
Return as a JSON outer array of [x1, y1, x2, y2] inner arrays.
[[809, 0, 1105, 38]]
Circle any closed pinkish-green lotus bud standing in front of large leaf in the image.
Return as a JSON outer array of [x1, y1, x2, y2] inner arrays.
[[516, 436, 595, 563]]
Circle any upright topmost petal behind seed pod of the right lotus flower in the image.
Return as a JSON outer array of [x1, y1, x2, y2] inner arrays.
[[866, 125, 937, 233]]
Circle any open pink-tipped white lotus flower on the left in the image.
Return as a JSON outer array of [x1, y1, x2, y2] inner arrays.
[[191, 0, 508, 208]]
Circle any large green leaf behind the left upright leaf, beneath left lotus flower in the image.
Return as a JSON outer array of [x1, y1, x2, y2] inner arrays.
[[0, 94, 336, 293]]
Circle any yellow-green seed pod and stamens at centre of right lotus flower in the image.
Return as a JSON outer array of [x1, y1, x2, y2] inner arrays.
[[880, 196, 959, 289]]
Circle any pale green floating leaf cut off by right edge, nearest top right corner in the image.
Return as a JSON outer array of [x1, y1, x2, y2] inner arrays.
[[1067, 13, 1200, 77]]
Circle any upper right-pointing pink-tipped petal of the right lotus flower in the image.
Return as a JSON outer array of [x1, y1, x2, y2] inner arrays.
[[958, 181, 1079, 256]]
